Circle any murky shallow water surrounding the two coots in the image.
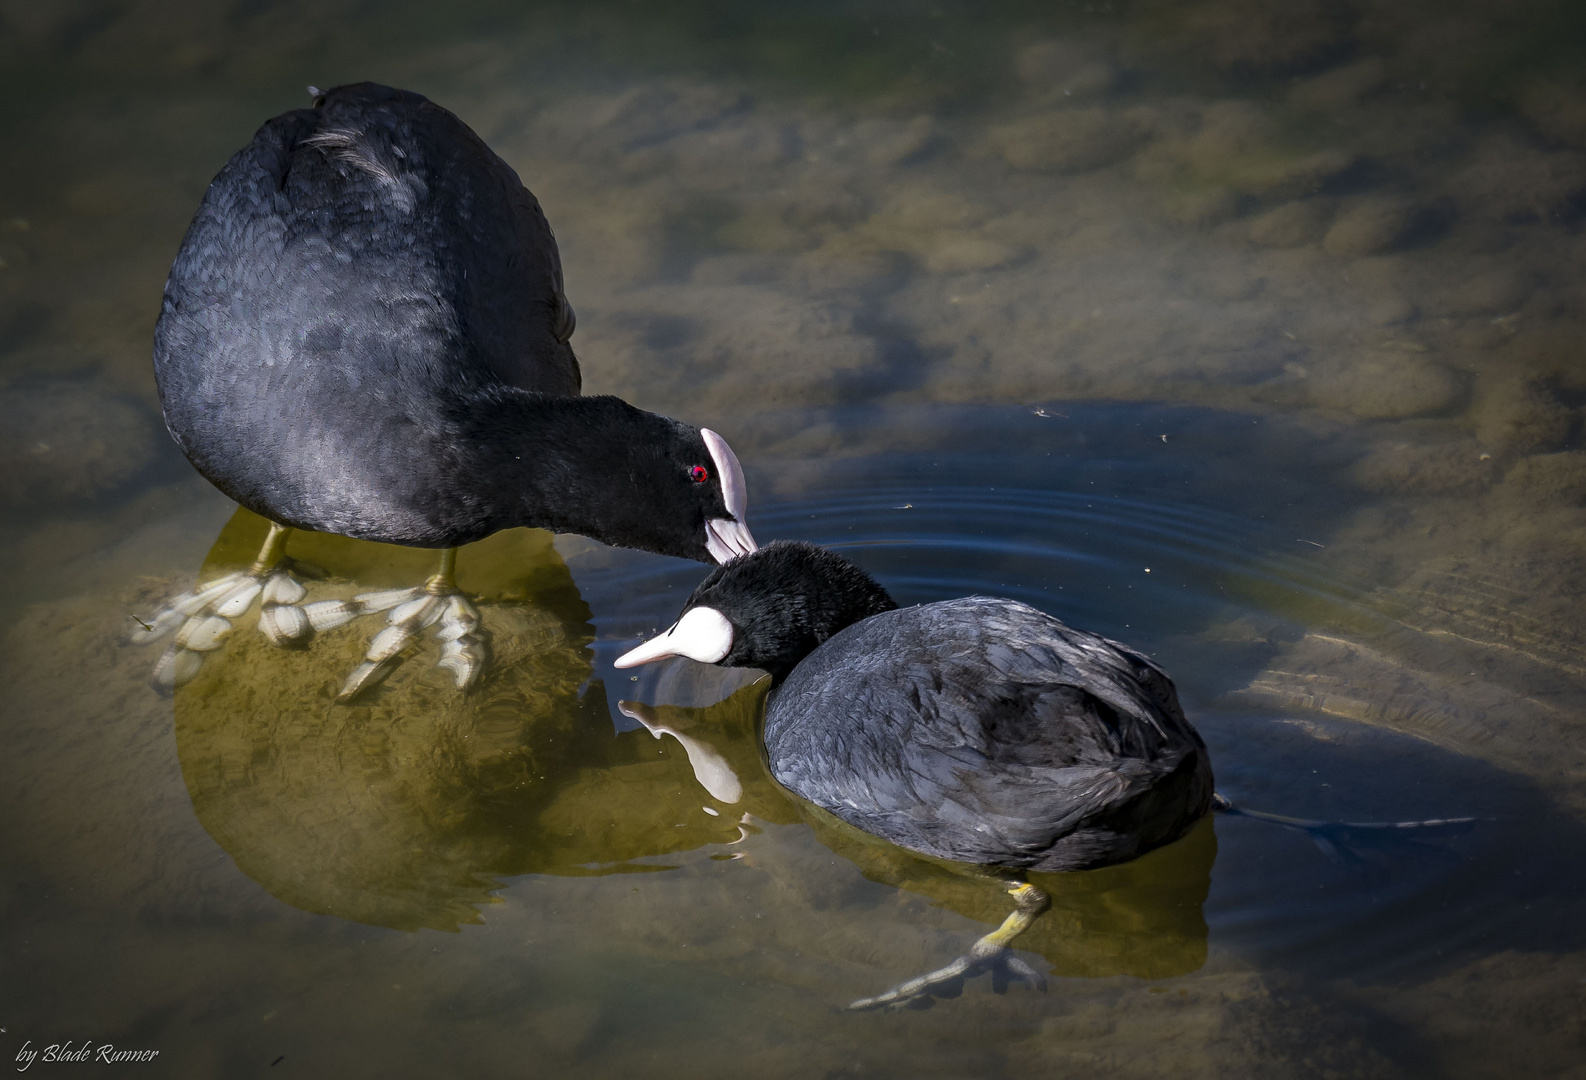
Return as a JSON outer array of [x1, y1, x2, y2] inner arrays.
[[0, 0, 1586, 1077]]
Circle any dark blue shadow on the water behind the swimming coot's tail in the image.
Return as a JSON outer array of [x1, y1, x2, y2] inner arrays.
[[1201, 712, 1586, 982]]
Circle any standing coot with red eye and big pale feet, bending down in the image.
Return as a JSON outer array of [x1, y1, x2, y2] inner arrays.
[[141, 82, 755, 696]]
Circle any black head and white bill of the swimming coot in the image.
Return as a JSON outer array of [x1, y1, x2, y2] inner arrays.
[[617, 541, 898, 682]]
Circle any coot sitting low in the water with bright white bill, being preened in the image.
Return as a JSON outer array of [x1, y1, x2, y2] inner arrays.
[[617, 541, 1213, 1007]]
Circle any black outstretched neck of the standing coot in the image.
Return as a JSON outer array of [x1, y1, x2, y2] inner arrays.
[[458, 387, 707, 560]]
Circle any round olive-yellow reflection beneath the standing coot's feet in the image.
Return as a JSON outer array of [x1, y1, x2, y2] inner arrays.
[[174, 511, 606, 929]]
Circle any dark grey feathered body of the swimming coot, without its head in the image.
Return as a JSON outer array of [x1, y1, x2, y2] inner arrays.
[[766, 598, 1201, 864]]
